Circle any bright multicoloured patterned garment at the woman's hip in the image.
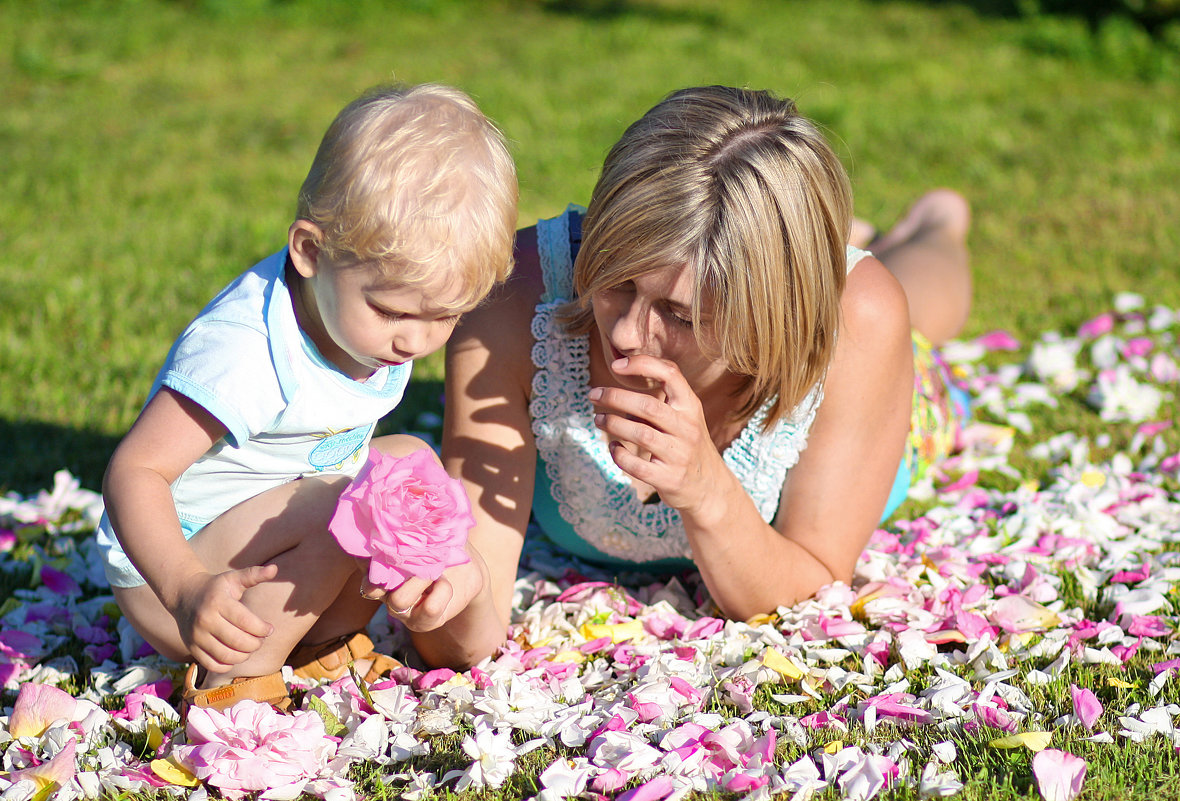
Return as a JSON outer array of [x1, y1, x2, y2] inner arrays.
[[881, 331, 971, 523]]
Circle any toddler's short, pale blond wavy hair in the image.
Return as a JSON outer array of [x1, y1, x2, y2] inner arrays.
[[296, 84, 517, 308]]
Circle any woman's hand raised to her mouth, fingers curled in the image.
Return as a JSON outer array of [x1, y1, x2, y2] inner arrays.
[[590, 355, 733, 516]]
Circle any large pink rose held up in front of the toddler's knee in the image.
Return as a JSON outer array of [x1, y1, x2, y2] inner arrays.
[[328, 448, 476, 590]]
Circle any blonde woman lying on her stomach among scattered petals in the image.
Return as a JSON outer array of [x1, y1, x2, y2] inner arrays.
[[387, 86, 970, 665]]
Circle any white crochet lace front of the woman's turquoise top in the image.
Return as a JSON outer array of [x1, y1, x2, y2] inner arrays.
[[530, 206, 863, 564]]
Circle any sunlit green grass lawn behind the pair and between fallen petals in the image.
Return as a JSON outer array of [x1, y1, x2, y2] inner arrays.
[[0, 0, 1180, 799]]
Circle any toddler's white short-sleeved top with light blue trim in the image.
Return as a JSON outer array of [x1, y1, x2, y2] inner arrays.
[[98, 249, 411, 586]]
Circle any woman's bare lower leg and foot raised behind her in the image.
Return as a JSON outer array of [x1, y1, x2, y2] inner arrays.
[[868, 189, 971, 344]]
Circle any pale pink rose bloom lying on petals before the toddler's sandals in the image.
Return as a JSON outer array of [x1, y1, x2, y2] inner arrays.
[[176, 700, 336, 799]]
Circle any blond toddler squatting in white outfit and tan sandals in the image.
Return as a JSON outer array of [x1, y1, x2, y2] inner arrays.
[[98, 85, 517, 708]]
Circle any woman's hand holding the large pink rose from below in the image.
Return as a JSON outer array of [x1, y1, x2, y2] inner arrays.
[[359, 545, 487, 631]]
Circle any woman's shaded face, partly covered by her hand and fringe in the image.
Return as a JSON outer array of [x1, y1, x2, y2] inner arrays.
[[590, 264, 734, 394]]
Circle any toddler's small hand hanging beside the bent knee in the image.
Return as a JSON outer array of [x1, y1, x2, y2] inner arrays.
[[171, 565, 278, 674]]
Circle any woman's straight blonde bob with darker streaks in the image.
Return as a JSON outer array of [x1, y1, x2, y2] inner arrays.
[[564, 86, 852, 429]]
